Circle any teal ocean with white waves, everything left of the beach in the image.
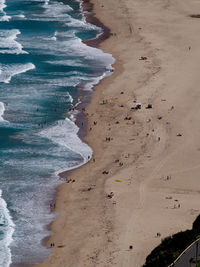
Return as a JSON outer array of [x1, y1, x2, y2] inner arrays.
[[0, 0, 114, 267]]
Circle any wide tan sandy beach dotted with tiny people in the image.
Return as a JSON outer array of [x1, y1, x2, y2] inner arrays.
[[38, 0, 200, 267]]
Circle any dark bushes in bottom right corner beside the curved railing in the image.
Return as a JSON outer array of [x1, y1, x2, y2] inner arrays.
[[143, 215, 200, 267]]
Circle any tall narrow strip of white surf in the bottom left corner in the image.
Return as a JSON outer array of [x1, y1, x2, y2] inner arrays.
[[0, 190, 15, 267]]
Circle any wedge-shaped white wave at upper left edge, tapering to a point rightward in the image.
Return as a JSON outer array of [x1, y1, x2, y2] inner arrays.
[[0, 63, 35, 83]]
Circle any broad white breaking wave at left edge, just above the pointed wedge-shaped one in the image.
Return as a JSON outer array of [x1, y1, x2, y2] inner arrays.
[[0, 29, 28, 54]]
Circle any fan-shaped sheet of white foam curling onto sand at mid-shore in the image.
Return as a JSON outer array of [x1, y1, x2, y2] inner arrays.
[[40, 118, 92, 172]]
